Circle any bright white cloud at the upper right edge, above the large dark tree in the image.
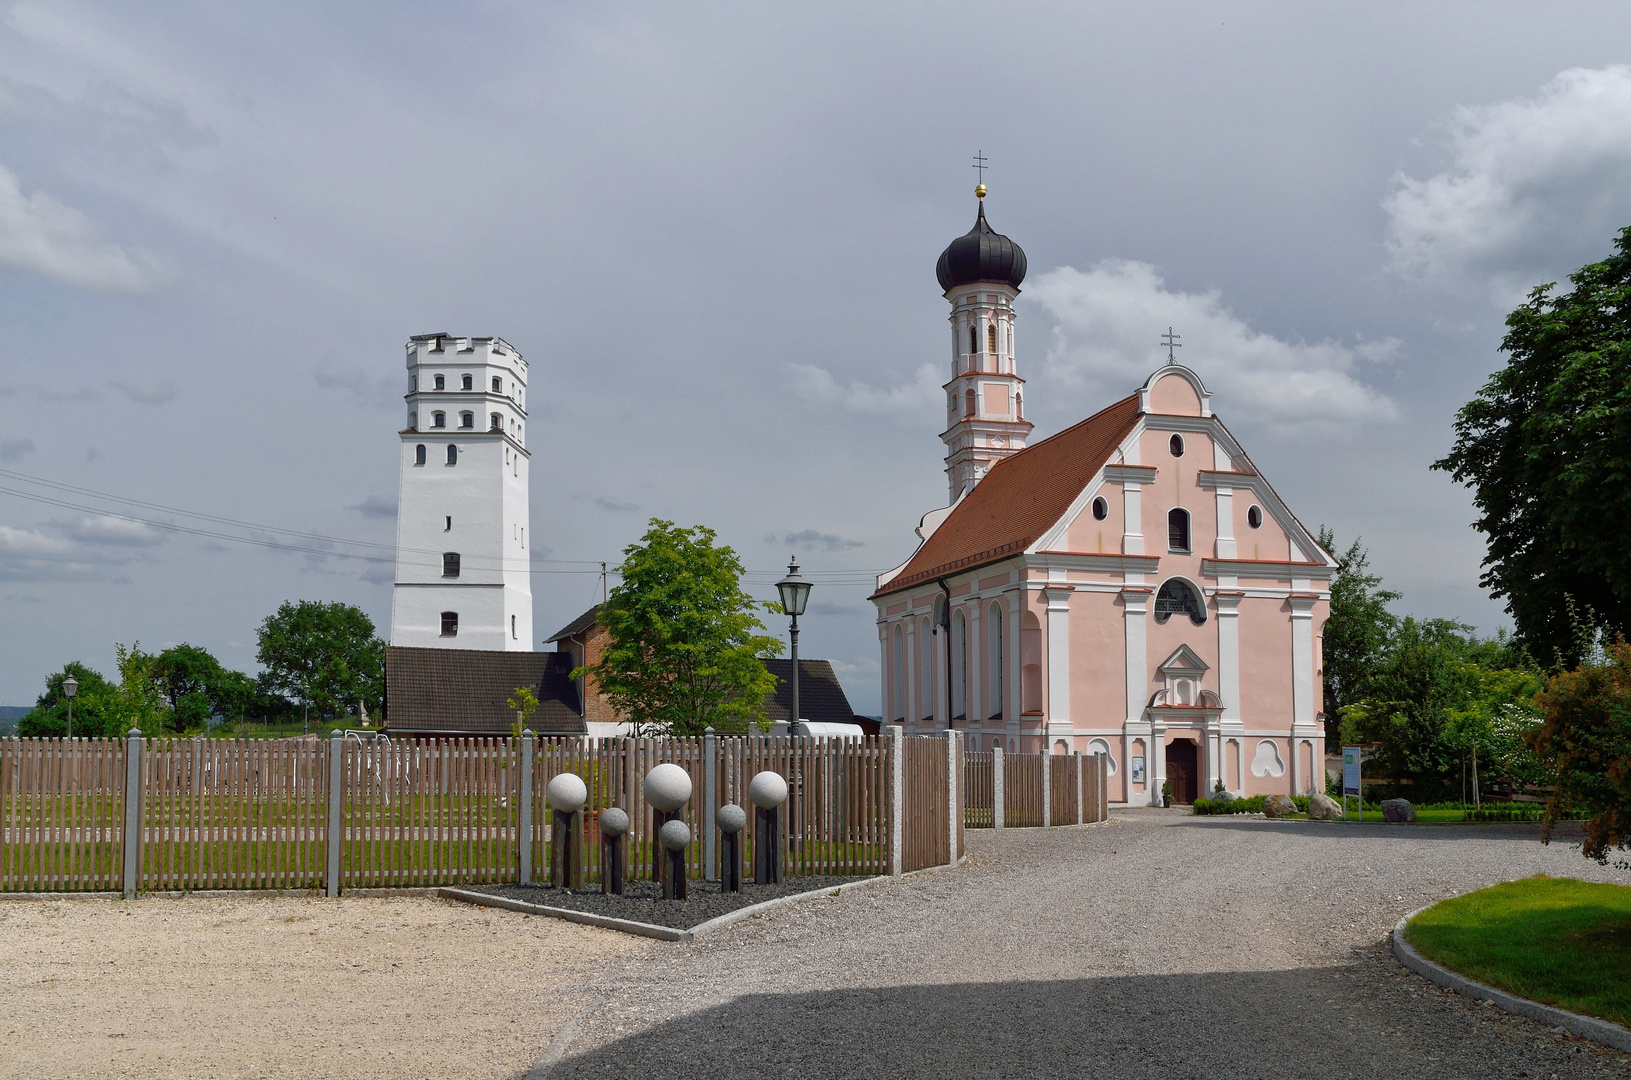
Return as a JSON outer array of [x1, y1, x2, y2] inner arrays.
[[1383, 65, 1631, 302]]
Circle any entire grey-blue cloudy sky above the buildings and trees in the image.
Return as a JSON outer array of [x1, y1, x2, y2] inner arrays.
[[0, 0, 1631, 711]]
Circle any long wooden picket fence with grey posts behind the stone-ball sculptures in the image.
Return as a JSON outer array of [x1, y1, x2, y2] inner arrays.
[[0, 733, 964, 894]]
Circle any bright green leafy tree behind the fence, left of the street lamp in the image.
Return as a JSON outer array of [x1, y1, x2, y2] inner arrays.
[[572, 517, 781, 736]]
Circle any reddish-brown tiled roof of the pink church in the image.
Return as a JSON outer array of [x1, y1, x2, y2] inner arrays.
[[874, 395, 1138, 595]]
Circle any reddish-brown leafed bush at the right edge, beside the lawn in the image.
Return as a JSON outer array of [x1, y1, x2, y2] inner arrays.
[[1530, 640, 1631, 866]]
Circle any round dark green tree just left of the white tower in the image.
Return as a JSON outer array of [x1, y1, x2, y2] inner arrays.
[[254, 600, 385, 727]]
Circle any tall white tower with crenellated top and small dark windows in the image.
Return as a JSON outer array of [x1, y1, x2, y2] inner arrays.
[[391, 334, 532, 653]]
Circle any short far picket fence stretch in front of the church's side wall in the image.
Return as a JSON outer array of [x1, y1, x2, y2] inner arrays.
[[962, 749, 1109, 829]]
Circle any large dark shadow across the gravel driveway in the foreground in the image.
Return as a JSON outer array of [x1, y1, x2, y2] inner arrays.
[[548, 965, 1626, 1080]]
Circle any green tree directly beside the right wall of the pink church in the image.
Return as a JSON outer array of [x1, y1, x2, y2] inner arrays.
[[1319, 525, 1401, 746]]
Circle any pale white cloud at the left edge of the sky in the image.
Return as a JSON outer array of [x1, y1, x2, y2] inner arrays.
[[0, 165, 170, 292]]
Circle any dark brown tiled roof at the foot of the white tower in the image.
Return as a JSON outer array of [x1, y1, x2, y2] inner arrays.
[[385, 646, 584, 736]]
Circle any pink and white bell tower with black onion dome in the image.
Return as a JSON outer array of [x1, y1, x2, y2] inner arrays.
[[935, 184, 1031, 502]]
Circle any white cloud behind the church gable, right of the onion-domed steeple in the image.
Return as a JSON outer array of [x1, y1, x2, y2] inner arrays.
[[1021, 259, 1399, 431]]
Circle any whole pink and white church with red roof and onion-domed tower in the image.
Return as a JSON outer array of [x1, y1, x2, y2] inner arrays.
[[873, 189, 1336, 804]]
